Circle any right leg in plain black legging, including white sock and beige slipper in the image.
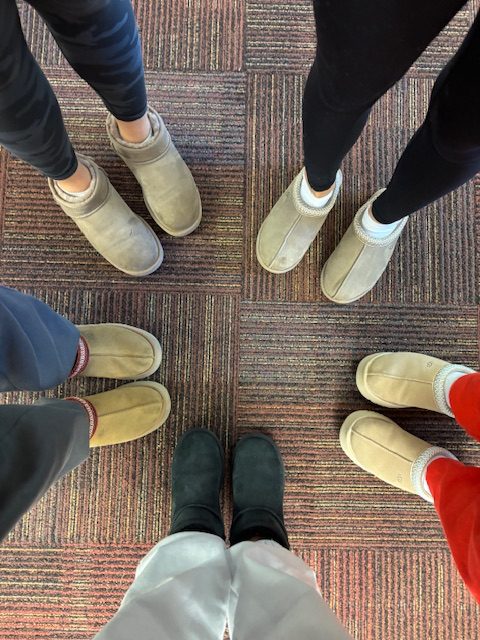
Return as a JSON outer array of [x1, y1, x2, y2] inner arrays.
[[321, 8, 480, 304]]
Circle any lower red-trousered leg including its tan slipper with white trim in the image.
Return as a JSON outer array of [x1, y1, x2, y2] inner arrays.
[[340, 411, 480, 598]]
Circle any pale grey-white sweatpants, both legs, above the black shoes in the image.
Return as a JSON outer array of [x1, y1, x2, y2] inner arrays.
[[94, 532, 351, 640]]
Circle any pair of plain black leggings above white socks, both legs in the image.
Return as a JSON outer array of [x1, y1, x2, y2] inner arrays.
[[303, 0, 480, 223]]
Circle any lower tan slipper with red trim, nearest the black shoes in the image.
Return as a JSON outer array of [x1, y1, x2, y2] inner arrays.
[[67, 381, 171, 447]]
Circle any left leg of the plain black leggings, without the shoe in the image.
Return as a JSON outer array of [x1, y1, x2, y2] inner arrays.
[[303, 0, 465, 191]]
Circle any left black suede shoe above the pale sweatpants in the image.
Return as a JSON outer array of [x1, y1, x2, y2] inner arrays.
[[170, 429, 225, 539]]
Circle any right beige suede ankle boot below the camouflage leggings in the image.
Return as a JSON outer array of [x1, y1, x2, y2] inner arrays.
[[107, 107, 202, 236]]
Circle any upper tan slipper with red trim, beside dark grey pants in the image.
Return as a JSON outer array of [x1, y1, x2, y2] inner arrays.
[[77, 323, 162, 380]]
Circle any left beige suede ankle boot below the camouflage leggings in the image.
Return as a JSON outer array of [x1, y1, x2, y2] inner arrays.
[[48, 154, 163, 276]]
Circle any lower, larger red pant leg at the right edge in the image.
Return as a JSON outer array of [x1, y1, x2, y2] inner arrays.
[[426, 458, 480, 602]]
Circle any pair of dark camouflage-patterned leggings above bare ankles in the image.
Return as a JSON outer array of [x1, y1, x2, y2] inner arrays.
[[0, 0, 147, 180]]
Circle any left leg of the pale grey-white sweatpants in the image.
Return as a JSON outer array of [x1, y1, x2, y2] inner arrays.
[[95, 531, 230, 640]]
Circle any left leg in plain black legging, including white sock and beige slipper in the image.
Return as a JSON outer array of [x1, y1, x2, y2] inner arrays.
[[257, 0, 464, 273]]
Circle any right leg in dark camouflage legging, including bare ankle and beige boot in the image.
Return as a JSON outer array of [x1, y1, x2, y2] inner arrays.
[[29, 0, 202, 236]]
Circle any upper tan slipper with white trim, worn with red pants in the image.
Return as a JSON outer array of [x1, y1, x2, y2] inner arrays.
[[357, 352, 473, 417]]
